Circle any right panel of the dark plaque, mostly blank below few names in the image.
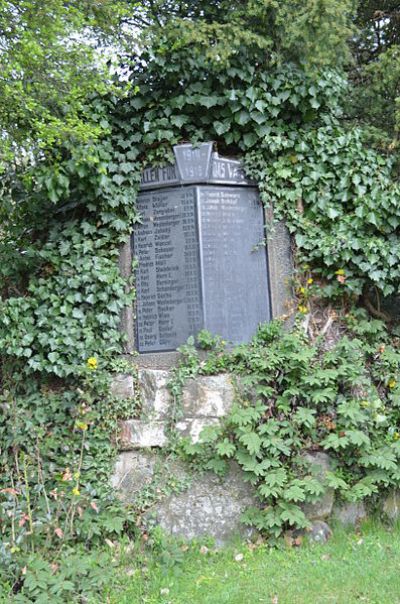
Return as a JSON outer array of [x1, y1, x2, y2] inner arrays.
[[198, 186, 270, 344]]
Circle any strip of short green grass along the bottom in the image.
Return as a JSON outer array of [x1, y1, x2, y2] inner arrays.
[[101, 523, 400, 604]]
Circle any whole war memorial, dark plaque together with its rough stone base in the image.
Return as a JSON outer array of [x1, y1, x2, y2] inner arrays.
[[112, 143, 292, 543]]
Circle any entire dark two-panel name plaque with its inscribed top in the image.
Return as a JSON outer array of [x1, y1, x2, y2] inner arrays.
[[133, 144, 271, 352]]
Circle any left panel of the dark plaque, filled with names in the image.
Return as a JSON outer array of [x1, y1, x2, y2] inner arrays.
[[133, 187, 203, 352]]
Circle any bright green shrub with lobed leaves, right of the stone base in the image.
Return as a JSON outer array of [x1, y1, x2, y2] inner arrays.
[[180, 323, 400, 537]]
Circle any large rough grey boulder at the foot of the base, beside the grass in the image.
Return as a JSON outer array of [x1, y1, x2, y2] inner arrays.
[[149, 463, 256, 545]]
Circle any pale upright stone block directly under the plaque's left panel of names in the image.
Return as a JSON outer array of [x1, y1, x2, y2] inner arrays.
[[138, 369, 171, 420]]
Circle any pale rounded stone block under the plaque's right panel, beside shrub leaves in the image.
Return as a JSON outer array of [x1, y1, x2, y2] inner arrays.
[[182, 374, 235, 417]]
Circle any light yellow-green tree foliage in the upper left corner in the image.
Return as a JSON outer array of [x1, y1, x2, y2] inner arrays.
[[0, 0, 130, 160]]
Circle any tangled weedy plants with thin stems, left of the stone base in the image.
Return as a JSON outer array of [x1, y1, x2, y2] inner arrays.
[[0, 359, 138, 602]]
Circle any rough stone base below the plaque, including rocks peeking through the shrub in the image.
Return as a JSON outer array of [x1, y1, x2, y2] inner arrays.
[[111, 368, 376, 544]]
